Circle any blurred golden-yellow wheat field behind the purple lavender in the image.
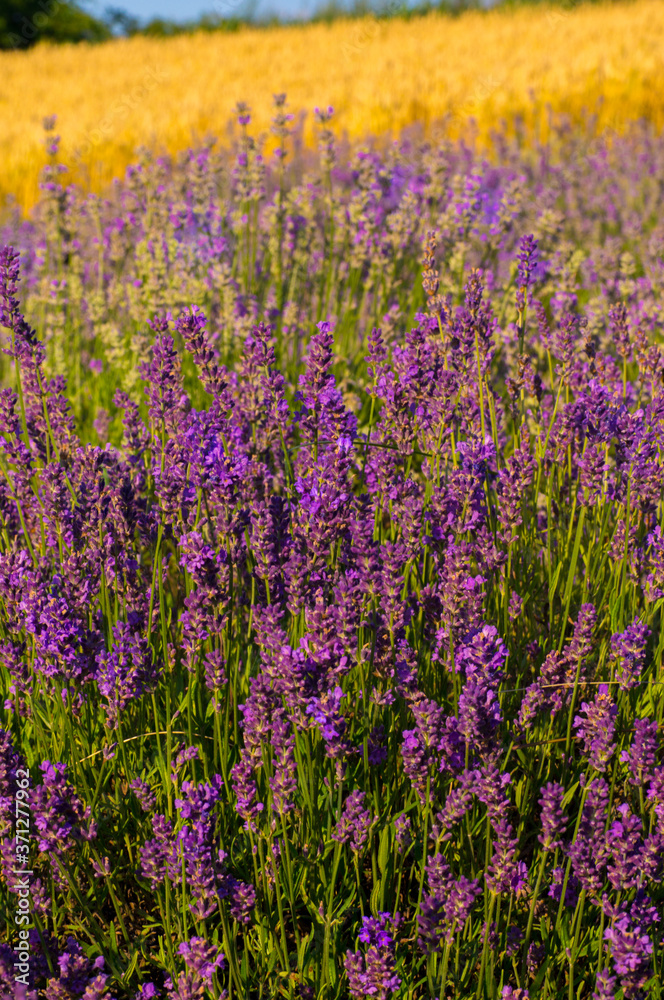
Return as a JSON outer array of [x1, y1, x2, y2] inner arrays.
[[0, 0, 664, 209]]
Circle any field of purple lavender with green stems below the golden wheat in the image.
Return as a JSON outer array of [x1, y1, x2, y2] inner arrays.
[[0, 103, 664, 1000]]
